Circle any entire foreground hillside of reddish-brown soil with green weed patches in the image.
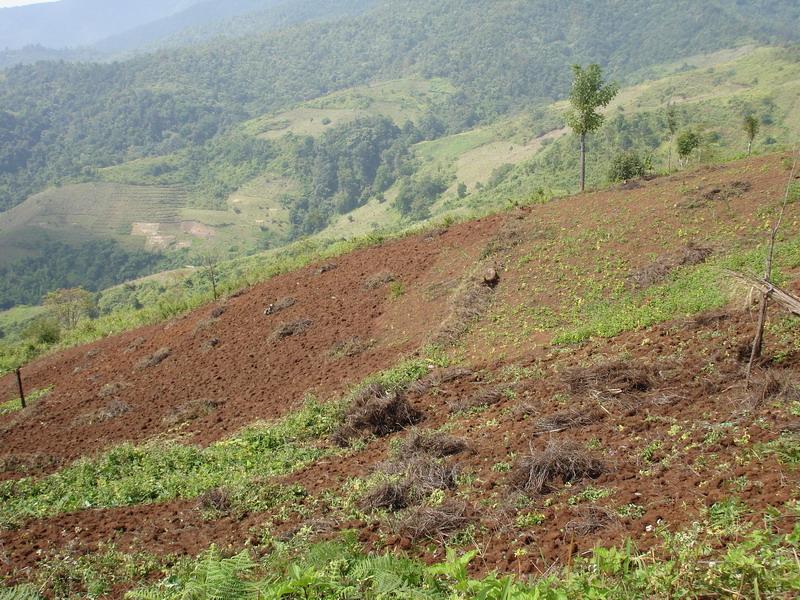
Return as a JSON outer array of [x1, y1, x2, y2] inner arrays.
[[0, 154, 800, 598]]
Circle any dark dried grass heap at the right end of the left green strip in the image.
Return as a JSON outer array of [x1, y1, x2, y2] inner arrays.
[[333, 383, 422, 446]]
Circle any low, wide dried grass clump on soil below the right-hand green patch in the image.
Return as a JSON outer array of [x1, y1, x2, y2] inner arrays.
[[562, 361, 655, 394]]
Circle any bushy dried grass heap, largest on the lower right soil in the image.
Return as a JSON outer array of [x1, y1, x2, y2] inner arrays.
[[509, 442, 606, 494]]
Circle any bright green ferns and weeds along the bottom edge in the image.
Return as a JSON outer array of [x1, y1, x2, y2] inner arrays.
[[115, 524, 800, 600]]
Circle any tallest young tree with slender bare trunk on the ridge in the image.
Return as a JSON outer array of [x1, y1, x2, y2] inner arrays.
[[567, 64, 619, 192]]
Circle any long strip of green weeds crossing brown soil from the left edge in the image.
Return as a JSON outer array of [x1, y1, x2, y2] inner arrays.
[[0, 400, 339, 526]]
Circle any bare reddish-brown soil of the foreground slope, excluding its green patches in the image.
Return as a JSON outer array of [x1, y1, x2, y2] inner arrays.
[[0, 156, 800, 596]]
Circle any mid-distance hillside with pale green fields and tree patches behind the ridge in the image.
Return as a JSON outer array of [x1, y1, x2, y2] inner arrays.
[[0, 46, 800, 306]]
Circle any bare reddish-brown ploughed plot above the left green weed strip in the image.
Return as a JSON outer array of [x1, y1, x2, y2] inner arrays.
[[0, 218, 500, 478]]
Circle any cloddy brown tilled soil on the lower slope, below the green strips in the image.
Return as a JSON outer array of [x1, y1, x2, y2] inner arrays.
[[3, 313, 800, 577]]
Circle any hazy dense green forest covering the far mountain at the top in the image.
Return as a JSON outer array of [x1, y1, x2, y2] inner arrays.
[[0, 0, 800, 209]]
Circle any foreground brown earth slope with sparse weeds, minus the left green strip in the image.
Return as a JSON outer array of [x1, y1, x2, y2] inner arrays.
[[0, 155, 800, 597]]
